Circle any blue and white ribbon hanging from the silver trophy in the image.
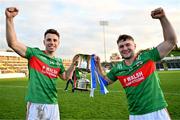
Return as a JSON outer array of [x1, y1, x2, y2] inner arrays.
[[90, 55, 109, 97]]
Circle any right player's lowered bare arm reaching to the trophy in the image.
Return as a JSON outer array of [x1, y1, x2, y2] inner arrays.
[[95, 56, 113, 85]]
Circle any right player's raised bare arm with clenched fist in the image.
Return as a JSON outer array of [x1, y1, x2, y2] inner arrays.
[[151, 8, 177, 58]]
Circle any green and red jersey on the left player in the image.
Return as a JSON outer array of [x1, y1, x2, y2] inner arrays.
[[26, 47, 65, 104]]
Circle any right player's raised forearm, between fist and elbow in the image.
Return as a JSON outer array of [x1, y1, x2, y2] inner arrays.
[[160, 16, 177, 46]]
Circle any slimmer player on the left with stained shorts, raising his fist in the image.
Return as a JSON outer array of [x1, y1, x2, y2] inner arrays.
[[5, 7, 78, 120]]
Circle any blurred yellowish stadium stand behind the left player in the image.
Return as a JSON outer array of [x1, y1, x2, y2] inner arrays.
[[0, 50, 71, 78]]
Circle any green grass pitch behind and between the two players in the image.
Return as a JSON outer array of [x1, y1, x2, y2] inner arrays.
[[0, 71, 180, 120]]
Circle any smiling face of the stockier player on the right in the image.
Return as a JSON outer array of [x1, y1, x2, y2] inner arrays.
[[118, 39, 136, 59]]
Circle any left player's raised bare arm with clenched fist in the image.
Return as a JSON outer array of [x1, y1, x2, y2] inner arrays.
[[5, 7, 27, 57]]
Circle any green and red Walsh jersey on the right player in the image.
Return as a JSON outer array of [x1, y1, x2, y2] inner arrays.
[[107, 48, 167, 115]]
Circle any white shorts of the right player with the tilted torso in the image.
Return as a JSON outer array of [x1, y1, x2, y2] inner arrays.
[[129, 108, 171, 120]]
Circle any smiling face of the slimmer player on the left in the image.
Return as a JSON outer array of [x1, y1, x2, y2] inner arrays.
[[44, 33, 60, 52]]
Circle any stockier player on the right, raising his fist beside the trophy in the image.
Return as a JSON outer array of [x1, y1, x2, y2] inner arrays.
[[95, 8, 177, 120]]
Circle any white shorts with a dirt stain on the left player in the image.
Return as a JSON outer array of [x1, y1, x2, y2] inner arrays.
[[26, 102, 60, 120]]
